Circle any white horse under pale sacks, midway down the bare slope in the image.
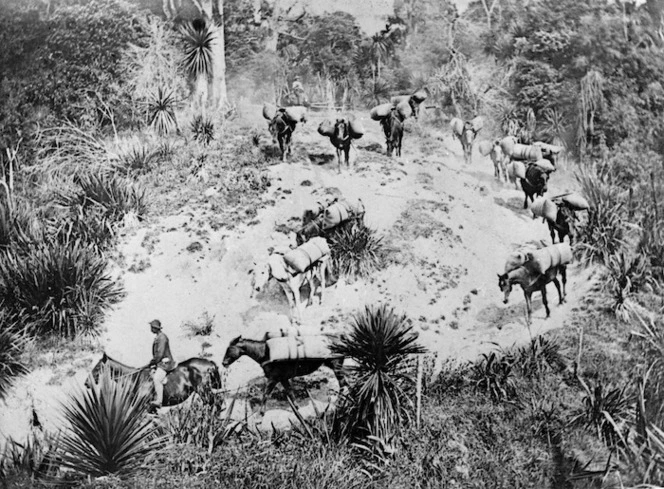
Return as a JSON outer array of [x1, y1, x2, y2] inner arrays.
[[249, 253, 329, 323]]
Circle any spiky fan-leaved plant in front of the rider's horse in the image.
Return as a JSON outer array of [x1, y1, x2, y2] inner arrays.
[[59, 371, 165, 477]]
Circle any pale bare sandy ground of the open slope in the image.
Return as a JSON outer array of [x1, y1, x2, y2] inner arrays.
[[0, 109, 591, 439]]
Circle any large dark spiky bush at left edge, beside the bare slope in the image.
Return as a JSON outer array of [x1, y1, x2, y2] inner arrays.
[[0, 241, 121, 337]]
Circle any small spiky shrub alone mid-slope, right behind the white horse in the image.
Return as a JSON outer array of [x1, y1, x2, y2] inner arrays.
[[328, 220, 383, 278]]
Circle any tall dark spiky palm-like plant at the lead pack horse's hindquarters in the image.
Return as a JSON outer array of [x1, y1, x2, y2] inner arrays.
[[331, 305, 425, 441]]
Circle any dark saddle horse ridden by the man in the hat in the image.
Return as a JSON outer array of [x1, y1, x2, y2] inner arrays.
[[85, 353, 221, 406]]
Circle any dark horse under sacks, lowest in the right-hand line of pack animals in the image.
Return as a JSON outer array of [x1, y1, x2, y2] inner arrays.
[[498, 264, 567, 323]]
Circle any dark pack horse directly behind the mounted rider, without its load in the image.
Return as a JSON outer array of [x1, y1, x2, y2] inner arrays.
[[221, 336, 346, 412]]
